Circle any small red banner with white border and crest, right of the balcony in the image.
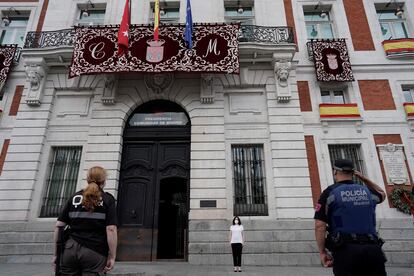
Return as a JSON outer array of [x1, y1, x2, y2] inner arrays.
[[310, 39, 354, 82]]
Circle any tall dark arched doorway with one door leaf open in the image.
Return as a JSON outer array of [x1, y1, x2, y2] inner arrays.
[[117, 100, 191, 261]]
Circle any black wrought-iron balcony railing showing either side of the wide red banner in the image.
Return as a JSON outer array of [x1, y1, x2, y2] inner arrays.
[[24, 25, 294, 49]]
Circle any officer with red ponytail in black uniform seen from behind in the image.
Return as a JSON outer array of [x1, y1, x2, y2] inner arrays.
[[53, 167, 117, 276]]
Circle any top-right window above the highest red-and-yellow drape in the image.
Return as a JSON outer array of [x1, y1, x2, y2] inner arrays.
[[377, 10, 408, 40]]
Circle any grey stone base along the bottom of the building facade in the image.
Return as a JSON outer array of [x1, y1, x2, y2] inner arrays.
[[0, 218, 414, 267]]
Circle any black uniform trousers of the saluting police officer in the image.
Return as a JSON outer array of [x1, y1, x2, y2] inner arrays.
[[332, 243, 387, 276]]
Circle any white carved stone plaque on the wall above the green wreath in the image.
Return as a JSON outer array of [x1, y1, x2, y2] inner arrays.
[[378, 143, 410, 185]]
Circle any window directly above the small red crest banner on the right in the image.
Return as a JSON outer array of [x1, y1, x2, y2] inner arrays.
[[304, 10, 334, 39]]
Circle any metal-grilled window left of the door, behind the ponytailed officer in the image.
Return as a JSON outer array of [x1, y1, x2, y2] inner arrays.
[[40, 147, 82, 217]]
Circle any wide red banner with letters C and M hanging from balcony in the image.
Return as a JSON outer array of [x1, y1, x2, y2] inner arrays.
[[69, 24, 239, 77]]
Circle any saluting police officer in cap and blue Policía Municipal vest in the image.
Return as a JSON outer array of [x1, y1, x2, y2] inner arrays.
[[314, 159, 387, 276]]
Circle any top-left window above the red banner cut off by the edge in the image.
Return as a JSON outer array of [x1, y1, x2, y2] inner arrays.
[[0, 12, 29, 47]]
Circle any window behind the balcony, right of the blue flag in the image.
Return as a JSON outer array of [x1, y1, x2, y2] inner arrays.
[[224, 1, 254, 25]]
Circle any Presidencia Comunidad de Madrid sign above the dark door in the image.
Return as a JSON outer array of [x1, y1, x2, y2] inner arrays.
[[129, 112, 188, 126]]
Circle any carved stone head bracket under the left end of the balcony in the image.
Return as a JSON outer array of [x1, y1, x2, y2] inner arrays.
[[25, 63, 47, 106]]
